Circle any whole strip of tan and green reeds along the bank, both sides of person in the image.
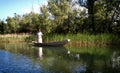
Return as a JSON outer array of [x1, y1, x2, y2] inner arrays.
[[0, 33, 120, 46]]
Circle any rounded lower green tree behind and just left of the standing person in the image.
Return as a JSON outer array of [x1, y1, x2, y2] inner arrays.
[[19, 12, 39, 33]]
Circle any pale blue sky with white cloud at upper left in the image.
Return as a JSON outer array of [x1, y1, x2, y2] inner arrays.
[[0, 0, 47, 20]]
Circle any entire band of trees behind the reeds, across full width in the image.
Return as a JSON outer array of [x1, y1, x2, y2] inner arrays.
[[0, 0, 120, 34]]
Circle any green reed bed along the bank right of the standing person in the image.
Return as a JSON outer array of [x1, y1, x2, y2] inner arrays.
[[43, 33, 120, 46]]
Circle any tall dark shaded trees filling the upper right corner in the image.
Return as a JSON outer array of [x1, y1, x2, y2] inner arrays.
[[79, 0, 120, 33]]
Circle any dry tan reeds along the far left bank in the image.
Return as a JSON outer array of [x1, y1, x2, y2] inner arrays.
[[0, 33, 30, 43]]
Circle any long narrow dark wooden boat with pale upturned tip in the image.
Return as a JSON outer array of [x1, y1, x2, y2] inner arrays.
[[34, 39, 70, 47]]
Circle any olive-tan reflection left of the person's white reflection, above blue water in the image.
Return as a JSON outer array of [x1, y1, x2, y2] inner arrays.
[[0, 43, 38, 58]]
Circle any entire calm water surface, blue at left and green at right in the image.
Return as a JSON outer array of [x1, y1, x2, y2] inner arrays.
[[0, 43, 120, 73]]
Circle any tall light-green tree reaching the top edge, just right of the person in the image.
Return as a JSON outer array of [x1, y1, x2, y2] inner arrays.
[[48, 0, 70, 32]]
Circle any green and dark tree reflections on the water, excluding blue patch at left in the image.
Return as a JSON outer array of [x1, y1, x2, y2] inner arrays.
[[0, 44, 120, 73]]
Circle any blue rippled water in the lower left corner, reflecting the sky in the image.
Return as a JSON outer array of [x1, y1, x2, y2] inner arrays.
[[0, 50, 42, 73]]
